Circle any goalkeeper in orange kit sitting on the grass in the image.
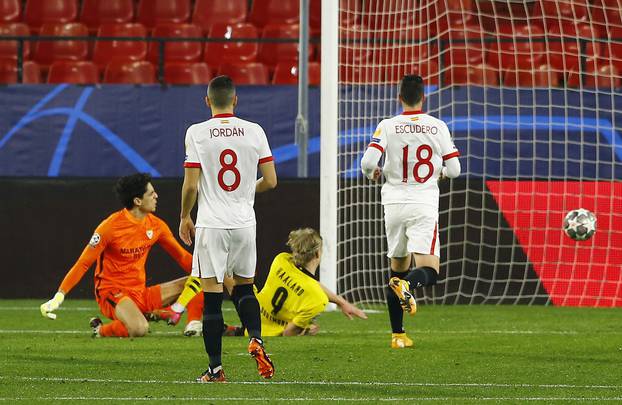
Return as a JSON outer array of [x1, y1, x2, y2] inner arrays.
[[41, 173, 203, 337]]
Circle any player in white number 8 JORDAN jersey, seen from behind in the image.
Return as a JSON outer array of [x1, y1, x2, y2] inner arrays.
[[179, 76, 277, 382]]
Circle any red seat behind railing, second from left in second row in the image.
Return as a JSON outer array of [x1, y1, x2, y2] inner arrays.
[[34, 23, 89, 65]]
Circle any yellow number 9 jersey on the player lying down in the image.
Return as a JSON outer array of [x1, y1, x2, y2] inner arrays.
[[257, 253, 328, 336]]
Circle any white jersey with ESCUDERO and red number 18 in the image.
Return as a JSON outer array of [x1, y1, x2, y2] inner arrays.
[[372, 112, 457, 206]]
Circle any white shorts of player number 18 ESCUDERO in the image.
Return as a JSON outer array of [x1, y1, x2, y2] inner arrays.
[[384, 204, 441, 257]]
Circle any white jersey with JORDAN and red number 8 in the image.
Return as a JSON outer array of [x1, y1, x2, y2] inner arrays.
[[185, 114, 271, 229]]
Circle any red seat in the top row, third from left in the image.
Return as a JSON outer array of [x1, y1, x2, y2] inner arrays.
[[80, 0, 134, 34]]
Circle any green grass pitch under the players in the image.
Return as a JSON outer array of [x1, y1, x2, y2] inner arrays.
[[0, 300, 622, 404]]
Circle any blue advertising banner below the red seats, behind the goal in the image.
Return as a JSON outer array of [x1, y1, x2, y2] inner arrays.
[[0, 84, 622, 179]]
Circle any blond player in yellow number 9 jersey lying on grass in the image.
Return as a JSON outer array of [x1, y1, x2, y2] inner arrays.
[[172, 228, 367, 336]]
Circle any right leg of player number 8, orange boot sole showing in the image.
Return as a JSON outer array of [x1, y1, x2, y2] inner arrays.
[[227, 226, 274, 378]]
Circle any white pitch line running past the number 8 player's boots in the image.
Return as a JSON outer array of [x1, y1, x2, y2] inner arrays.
[[0, 376, 622, 389]]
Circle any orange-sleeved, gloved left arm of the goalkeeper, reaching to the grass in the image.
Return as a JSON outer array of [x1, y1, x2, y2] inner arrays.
[[39, 226, 106, 319]]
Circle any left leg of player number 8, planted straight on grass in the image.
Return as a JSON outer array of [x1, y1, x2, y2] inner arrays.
[[192, 228, 231, 382]]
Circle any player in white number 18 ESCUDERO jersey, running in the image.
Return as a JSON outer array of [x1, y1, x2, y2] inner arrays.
[[361, 75, 460, 348]]
